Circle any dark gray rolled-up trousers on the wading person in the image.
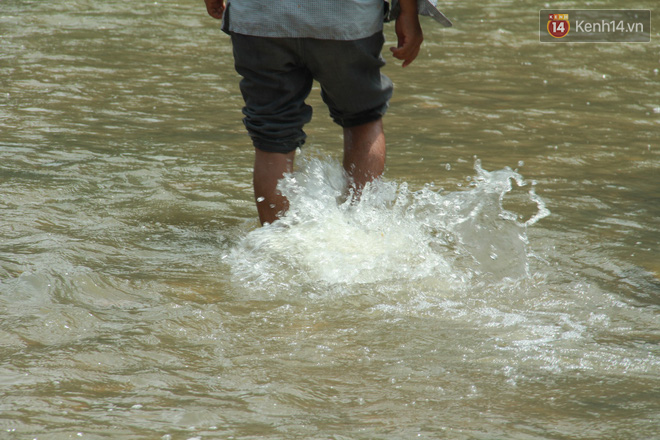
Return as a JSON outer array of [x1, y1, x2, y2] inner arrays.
[[231, 32, 392, 153]]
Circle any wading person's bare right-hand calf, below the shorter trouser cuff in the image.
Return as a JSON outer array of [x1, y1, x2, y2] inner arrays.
[[343, 119, 385, 192]]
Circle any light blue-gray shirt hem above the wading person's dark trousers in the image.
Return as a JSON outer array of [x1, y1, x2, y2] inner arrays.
[[223, 0, 385, 40]]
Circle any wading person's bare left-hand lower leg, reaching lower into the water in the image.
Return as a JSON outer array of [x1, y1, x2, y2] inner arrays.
[[253, 148, 296, 225]]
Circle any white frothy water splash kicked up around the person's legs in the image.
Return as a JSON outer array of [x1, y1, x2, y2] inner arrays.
[[228, 156, 549, 289]]
